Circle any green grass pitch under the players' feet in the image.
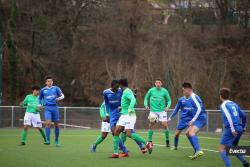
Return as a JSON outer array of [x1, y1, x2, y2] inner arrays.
[[0, 129, 250, 167]]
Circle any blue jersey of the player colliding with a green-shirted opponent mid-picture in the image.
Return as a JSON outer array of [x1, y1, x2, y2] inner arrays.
[[103, 88, 122, 118]]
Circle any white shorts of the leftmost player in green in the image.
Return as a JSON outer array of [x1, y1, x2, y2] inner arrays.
[[23, 112, 42, 128]]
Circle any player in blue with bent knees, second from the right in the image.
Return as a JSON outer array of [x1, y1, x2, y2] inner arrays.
[[168, 82, 207, 160]]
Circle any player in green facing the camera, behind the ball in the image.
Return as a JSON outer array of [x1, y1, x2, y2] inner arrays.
[[144, 79, 171, 147]]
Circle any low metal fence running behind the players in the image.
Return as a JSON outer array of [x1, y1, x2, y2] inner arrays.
[[0, 106, 250, 132]]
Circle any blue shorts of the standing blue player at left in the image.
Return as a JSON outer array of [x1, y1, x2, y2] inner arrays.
[[44, 106, 59, 122]]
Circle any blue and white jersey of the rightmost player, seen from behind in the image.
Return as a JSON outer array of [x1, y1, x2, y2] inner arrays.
[[220, 100, 246, 132]]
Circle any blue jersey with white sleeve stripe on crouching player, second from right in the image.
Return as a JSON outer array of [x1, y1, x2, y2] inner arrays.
[[169, 93, 206, 122]]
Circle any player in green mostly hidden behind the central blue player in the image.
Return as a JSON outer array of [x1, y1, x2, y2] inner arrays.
[[91, 102, 110, 152]]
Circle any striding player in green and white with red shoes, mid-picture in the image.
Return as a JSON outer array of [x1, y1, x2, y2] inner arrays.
[[111, 79, 152, 158]]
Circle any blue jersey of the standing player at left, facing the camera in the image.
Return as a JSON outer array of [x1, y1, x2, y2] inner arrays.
[[38, 86, 64, 106]]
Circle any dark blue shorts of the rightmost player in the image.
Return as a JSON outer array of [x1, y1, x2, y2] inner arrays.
[[220, 126, 243, 147]]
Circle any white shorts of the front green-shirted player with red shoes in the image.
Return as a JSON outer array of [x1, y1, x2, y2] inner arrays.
[[117, 115, 136, 130]]
